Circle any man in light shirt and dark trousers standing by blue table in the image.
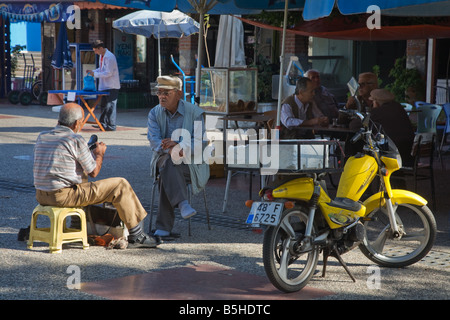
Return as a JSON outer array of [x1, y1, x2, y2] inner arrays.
[[86, 40, 120, 131]]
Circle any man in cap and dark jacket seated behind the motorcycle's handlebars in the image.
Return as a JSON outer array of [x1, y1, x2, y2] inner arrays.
[[370, 89, 415, 166]]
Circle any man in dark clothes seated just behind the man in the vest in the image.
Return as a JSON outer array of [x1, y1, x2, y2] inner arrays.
[[305, 69, 339, 122]]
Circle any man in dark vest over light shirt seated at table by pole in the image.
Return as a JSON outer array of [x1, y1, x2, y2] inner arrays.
[[280, 77, 329, 139]]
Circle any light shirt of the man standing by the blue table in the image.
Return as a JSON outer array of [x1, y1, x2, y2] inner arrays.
[[93, 49, 120, 91]]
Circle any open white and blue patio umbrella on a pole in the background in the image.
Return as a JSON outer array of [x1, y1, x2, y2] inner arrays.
[[113, 10, 200, 75]]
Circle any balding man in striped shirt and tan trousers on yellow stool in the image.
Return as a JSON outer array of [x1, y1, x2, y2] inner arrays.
[[33, 103, 160, 248]]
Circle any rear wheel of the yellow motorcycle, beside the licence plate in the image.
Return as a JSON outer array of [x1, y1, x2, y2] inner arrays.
[[263, 208, 319, 292]]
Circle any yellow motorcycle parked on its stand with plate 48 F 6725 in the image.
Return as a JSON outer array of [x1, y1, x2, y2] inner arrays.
[[247, 112, 436, 292]]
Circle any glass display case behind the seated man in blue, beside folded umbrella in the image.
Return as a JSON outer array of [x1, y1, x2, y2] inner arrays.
[[200, 68, 258, 114]]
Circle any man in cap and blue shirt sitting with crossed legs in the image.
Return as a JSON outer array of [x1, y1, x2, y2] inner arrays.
[[147, 76, 209, 240]]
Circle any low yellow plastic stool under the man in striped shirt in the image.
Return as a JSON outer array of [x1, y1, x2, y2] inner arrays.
[[27, 205, 89, 253]]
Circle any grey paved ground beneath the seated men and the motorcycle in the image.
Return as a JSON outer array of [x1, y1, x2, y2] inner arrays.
[[0, 101, 450, 312]]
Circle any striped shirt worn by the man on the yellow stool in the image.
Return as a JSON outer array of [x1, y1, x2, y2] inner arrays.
[[33, 125, 96, 191]]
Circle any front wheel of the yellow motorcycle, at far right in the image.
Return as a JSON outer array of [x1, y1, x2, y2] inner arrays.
[[359, 203, 436, 268]]
